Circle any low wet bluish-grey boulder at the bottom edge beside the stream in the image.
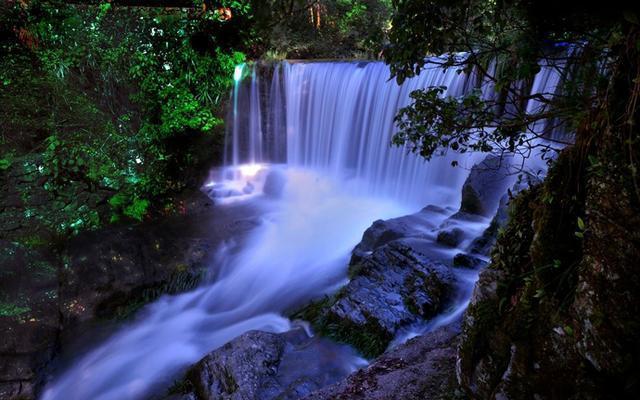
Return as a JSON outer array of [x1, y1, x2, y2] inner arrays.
[[181, 328, 358, 400]]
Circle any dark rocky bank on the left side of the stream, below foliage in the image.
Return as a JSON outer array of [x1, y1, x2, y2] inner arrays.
[[0, 188, 258, 399]]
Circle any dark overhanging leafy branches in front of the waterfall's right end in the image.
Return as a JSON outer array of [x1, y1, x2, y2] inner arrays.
[[384, 0, 635, 164]]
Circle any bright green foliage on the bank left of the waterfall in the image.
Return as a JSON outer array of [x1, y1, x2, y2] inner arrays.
[[0, 0, 252, 231]]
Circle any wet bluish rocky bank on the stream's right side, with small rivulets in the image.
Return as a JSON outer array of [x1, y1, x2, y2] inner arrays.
[[169, 157, 526, 400]]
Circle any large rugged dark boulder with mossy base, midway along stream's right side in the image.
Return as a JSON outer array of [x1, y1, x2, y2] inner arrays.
[[301, 240, 456, 356]]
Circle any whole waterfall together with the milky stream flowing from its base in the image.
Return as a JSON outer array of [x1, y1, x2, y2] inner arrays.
[[43, 57, 564, 400]]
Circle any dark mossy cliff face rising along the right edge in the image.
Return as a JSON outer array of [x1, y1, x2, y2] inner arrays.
[[457, 27, 640, 399]]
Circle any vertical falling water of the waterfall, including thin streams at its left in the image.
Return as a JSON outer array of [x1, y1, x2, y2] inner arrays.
[[220, 62, 490, 209]]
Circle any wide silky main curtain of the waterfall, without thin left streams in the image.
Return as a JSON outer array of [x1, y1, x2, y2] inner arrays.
[[285, 62, 482, 209]]
